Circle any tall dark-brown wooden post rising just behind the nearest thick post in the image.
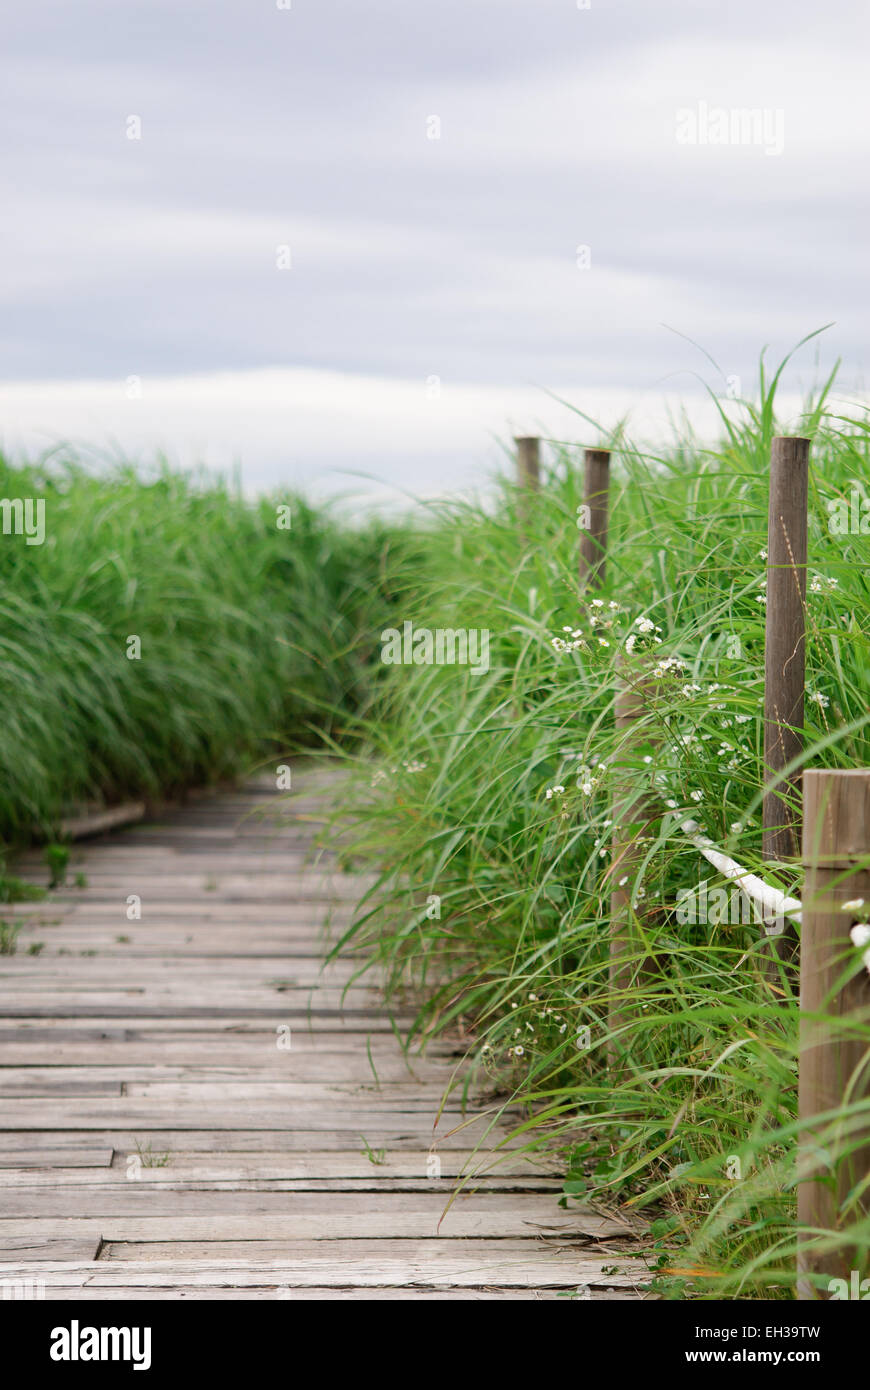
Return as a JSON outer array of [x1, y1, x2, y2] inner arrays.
[[762, 436, 810, 977]]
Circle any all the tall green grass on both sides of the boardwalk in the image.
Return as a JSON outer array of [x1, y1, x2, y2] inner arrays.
[[8, 353, 870, 1297]]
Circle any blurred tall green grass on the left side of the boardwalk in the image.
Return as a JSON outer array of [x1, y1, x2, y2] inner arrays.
[[0, 456, 397, 842]]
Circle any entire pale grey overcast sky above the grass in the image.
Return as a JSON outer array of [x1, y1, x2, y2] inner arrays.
[[0, 0, 870, 492]]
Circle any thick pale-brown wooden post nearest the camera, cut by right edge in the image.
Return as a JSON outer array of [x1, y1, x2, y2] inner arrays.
[[798, 767, 870, 1300]]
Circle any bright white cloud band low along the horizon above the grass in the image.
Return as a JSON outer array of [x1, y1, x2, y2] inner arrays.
[[0, 370, 799, 500]]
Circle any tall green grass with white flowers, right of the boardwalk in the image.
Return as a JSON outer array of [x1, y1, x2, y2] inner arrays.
[[322, 361, 870, 1297]]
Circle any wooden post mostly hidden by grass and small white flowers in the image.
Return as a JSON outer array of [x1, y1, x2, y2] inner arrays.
[[607, 667, 662, 1068]]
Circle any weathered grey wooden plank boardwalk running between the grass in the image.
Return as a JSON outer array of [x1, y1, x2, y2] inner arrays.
[[0, 767, 645, 1300]]
